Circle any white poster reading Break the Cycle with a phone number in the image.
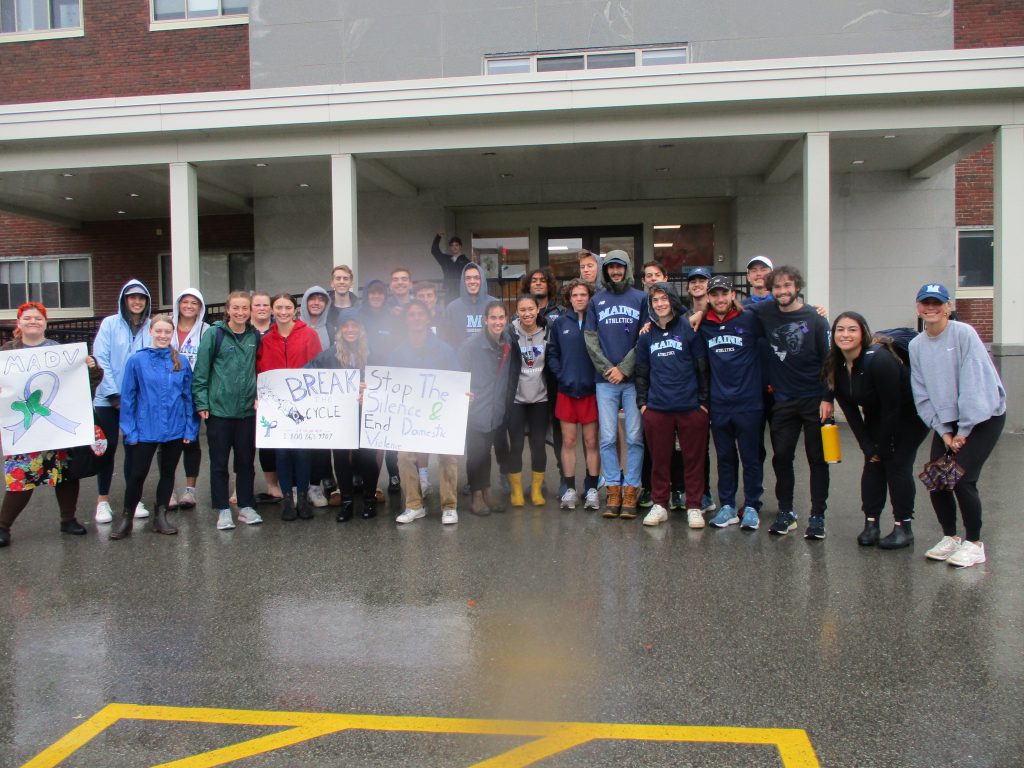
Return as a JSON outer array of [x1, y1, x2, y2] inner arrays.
[[256, 368, 359, 449]]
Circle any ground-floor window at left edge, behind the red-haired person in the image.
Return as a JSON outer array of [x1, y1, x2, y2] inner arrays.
[[0, 256, 92, 309]]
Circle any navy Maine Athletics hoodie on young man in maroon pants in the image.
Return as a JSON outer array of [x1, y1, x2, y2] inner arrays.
[[636, 283, 708, 413]]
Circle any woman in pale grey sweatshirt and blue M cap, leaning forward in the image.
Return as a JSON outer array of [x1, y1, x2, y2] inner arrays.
[[910, 283, 1007, 567]]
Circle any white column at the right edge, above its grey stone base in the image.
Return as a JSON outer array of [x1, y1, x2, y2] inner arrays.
[[992, 125, 1024, 345]]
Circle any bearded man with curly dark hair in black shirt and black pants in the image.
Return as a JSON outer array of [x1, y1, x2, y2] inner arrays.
[[751, 266, 833, 539]]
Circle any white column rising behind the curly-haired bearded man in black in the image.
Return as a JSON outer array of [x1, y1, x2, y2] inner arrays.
[[804, 133, 831, 308]]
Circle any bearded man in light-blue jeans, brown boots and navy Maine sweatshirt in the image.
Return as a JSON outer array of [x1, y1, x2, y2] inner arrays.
[[584, 250, 647, 519]]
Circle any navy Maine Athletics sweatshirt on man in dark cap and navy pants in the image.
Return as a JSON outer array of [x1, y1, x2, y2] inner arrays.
[[698, 309, 764, 414]]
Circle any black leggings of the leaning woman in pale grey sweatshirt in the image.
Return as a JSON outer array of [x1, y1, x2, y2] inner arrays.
[[931, 414, 1007, 542]]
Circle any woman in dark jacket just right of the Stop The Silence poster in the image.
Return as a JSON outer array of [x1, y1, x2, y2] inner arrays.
[[459, 299, 516, 516]]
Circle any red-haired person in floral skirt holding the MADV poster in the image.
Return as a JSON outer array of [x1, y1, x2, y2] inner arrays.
[[0, 301, 103, 547]]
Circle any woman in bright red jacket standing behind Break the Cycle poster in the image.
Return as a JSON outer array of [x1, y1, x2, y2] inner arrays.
[[256, 293, 322, 520]]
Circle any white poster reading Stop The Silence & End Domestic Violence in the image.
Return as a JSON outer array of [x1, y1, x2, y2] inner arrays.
[[359, 366, 469, 456]]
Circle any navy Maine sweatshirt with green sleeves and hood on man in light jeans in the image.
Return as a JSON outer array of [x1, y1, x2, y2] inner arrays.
[[584, 251, 647, 383]]
